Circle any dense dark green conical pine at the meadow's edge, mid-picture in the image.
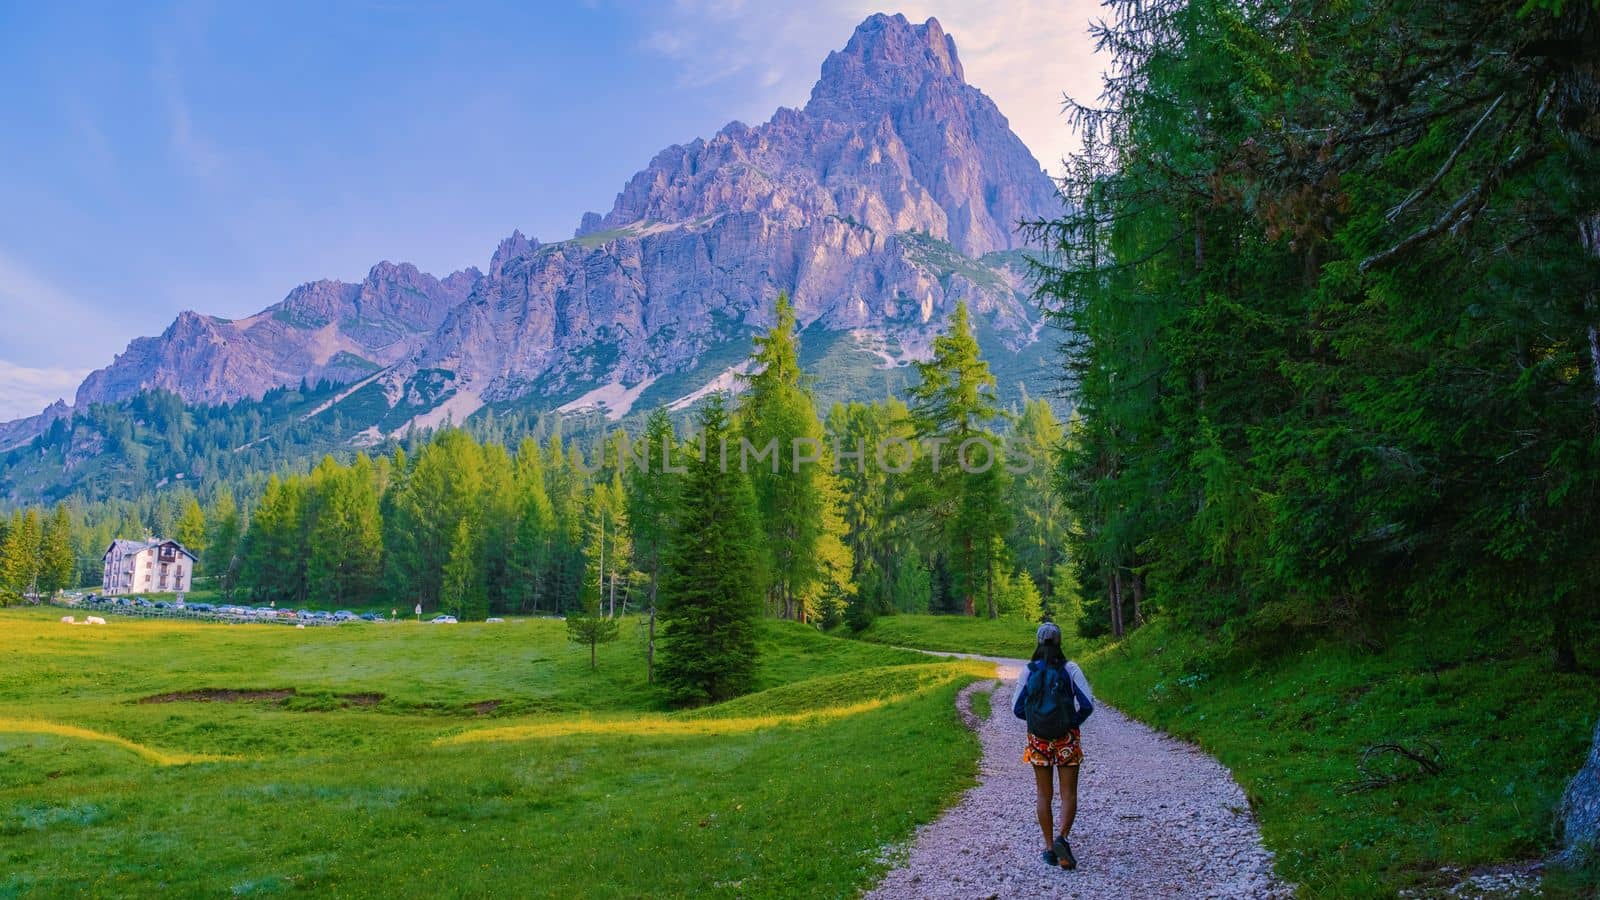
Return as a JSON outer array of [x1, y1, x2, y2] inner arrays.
[[659, 394, 762, 705]]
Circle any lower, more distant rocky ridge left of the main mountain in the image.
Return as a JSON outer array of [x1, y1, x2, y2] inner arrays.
[[75, 263, 480, 408]]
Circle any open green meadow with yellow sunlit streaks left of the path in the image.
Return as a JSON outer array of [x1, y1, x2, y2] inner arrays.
[[0, 609, 984, 897]]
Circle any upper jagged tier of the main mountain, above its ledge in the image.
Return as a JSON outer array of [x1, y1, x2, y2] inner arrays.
[[578, 14, 1058, 256]]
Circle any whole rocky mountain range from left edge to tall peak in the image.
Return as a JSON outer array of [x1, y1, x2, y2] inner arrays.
[[9, 14, 1058, 445]]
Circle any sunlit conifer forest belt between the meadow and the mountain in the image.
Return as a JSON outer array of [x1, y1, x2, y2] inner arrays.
[[0, 296, 1066, 703]]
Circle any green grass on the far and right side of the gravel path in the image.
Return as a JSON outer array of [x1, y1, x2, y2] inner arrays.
[[866, 615, 1600, 897]]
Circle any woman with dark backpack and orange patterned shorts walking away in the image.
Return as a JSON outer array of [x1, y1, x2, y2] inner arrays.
[[1011, 621, 1094, 870]]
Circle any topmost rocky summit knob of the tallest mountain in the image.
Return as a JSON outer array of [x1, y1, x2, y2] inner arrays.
[[806, 13, 966, 114]]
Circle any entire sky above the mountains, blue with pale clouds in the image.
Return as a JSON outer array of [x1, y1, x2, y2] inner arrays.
[[0, 0, 1099, 420]]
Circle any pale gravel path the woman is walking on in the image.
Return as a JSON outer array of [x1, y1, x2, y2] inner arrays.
[[867, 657, 1293, 900]]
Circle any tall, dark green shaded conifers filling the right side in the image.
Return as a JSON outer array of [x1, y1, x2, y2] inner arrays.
[[1043, 0, 1600, 666]]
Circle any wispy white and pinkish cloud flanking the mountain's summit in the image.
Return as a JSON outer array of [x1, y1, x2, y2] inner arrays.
[[630, 0, 1106, 171]]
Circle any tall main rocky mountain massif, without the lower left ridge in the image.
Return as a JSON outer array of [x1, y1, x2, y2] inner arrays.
[[389, 14, 1058, 416]]
